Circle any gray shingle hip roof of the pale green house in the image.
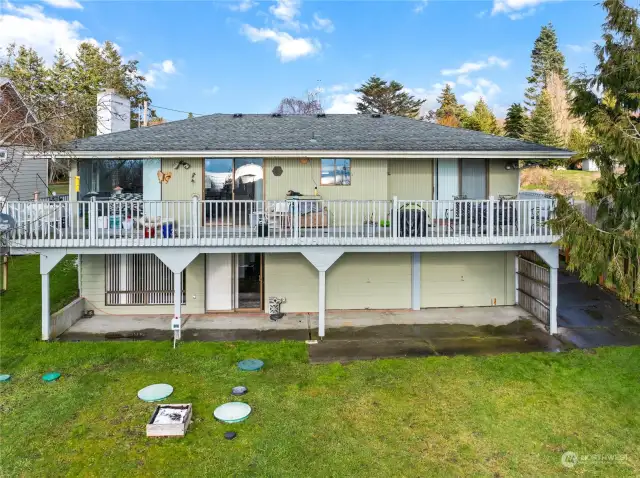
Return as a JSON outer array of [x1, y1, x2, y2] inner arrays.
[[70, 114, 566, 154]]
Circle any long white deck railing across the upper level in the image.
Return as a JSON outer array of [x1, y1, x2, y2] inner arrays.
[[4, 199, 557, 248]]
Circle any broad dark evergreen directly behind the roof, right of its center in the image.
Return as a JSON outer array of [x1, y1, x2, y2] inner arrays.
[[355, 75, 426, 118]]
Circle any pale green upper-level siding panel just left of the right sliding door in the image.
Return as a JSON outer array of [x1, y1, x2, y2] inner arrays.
[[387, 159, 433, 201]]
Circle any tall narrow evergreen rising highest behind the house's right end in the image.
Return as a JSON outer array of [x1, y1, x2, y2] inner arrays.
[[525, 23, 569, 111]]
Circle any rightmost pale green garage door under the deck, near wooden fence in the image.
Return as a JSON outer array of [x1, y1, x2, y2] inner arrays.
[[420, 252, 515, 308]]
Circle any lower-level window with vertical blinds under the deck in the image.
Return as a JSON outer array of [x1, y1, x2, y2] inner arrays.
[[105, 254, 186, 305]]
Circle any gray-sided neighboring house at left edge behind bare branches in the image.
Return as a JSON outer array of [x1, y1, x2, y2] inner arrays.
[[0, 77, 49, 202]]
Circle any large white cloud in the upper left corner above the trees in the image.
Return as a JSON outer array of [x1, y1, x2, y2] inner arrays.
[[0, 2, 99, 62]]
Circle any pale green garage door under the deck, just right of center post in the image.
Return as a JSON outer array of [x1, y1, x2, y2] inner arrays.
[[327, 252, 411, 309]]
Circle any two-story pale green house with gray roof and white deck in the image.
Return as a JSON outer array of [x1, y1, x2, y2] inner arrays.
[[5, 92, 572, 338]]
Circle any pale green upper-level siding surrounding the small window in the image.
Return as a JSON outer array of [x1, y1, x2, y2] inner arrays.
[[264, 158, 388, 200]]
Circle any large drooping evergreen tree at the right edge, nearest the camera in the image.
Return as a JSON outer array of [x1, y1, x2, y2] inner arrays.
[[551, 0, 640, 302]]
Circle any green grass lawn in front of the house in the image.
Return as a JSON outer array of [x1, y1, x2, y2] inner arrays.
[[0, 257, 640, 477]]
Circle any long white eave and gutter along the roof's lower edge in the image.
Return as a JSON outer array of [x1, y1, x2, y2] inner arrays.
[[32, 150, 574, 160]]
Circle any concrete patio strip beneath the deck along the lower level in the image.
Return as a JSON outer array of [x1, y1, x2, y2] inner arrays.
[[61, 306, 542, 341]]
